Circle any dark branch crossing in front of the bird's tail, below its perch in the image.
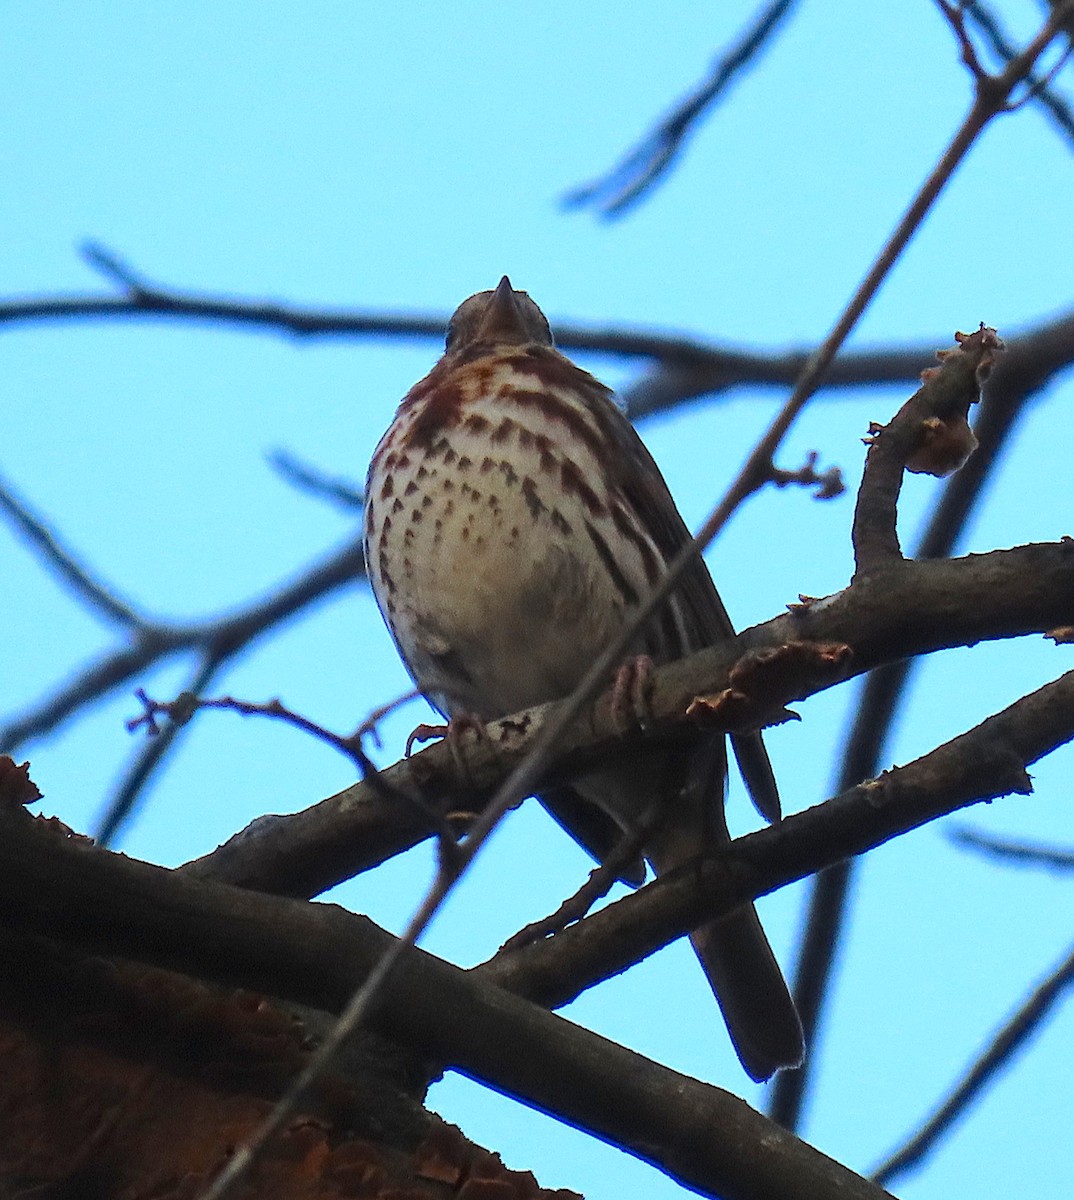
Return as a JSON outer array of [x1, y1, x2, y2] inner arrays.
[[482, 672, 1074, 1007]]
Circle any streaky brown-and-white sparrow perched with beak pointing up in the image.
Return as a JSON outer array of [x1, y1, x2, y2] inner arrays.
[[365, 277, 803, 1080]]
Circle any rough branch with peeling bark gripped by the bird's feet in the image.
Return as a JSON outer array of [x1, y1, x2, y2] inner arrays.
[[185, 542, 1074, 896]]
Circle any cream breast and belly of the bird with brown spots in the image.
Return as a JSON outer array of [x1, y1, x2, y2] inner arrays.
[[366, 374, 661, 715]]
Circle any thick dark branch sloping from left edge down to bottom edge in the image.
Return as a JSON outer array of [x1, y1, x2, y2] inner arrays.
[[0, 811, 886, 1200]]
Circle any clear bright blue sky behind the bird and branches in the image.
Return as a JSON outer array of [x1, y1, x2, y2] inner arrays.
[[0, 0, 1074, 1200]]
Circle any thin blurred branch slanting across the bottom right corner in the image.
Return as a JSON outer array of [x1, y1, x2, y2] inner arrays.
[[872, 936, 1074, 1186]]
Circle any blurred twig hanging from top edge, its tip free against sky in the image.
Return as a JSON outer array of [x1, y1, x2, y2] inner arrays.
[[563, 0, 793, 217]]
